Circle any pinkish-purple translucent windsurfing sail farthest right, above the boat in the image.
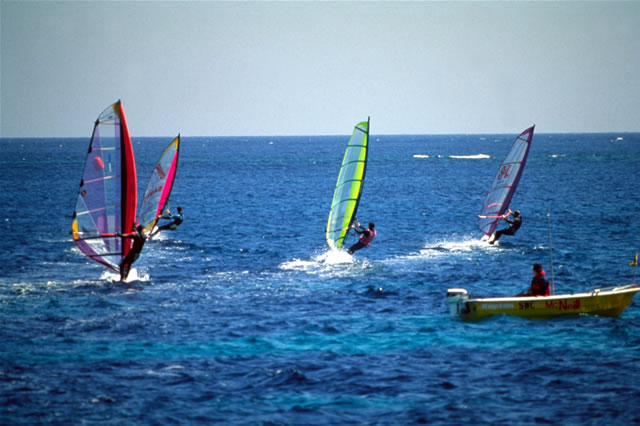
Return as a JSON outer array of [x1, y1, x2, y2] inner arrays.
[[478, 126, 535, 236]]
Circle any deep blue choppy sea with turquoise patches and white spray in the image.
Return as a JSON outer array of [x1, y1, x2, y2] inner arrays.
[[0, 131, 640, 425]]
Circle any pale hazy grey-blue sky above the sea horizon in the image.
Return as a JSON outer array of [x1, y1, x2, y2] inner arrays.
[[0, 0, 640, 137]]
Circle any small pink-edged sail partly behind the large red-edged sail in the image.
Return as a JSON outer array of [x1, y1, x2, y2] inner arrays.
[[138, 135, 180, 231]]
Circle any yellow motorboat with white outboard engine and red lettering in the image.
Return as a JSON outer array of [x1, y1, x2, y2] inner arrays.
[[447, 284, 640, 321]]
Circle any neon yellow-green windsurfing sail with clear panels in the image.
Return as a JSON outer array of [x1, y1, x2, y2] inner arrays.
[[326, 119, 369, 250]]
